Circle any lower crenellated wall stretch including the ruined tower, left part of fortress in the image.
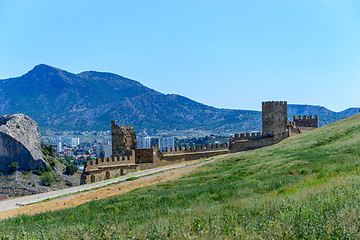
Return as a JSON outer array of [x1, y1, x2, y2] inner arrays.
[[80, 121, 229, 184]]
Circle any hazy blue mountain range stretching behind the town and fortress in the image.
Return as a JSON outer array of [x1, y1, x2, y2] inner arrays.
[[0, 64, 359, 133]]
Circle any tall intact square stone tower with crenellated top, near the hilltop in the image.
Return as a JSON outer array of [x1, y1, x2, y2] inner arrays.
[[262, 101, 288, 134]]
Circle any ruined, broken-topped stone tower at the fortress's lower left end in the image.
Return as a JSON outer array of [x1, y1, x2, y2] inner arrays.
[[111, 121, 137, 157]]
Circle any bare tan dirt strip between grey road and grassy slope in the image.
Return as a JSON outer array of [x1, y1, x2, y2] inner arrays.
[[0, 157, 214, 219]]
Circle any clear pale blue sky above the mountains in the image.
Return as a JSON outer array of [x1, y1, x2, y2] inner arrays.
[[0, 0, 360, 111]]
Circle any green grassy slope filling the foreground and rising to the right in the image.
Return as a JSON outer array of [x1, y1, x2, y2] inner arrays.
[[0, 114, 360, 239]]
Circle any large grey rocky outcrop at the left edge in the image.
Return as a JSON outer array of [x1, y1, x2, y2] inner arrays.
[[0, 114, 46, 171]]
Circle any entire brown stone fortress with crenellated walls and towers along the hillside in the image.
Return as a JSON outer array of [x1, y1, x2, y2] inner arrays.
[[80, 101, 318, 184]]
